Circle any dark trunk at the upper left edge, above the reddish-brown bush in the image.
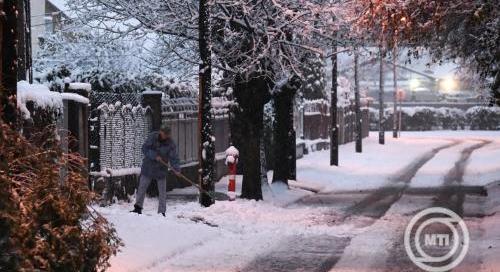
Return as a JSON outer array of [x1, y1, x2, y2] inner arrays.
[[0, 0, 18, 125]]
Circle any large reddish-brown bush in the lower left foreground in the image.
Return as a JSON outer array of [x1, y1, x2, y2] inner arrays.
[[0, 118, 121, 271]]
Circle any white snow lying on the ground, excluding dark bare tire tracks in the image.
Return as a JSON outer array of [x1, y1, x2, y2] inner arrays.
[[97, 131, 500, 271]]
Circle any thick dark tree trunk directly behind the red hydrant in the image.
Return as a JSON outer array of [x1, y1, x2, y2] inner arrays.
[[231, 75, 273, 200]]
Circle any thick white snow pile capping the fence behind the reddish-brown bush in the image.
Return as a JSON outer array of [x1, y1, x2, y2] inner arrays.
[[17, 81, 63, 119]]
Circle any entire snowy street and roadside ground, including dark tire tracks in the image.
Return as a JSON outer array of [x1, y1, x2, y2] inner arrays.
[[99, 132, 500, 271]]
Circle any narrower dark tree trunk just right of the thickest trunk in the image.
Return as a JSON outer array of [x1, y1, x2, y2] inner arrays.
[[273, 77, 301, 184]]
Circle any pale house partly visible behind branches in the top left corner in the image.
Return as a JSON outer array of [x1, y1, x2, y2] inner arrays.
[[30, 0, 68, 56]]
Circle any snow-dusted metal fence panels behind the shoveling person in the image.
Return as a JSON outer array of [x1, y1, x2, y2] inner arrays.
[[89, 93, 230, 176]]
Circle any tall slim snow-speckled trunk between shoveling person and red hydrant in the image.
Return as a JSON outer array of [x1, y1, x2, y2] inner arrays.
[[198, 0, 215, 207]]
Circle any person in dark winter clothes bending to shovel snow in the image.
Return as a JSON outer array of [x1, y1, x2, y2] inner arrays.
[[131, 126, 181, 216]]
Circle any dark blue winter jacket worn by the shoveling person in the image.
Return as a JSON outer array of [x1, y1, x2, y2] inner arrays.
[[141, 132, 181, 179]]
